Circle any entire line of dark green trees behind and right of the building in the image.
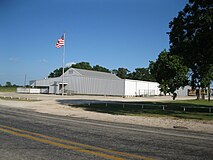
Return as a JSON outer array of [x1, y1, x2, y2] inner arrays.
[[49, 0, 213, 100]]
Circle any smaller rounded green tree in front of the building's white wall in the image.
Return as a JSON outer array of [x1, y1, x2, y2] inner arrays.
[[149, 50, 188, 94]]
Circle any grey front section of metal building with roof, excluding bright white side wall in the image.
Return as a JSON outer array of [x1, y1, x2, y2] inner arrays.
[[30, 68, 124, 96]]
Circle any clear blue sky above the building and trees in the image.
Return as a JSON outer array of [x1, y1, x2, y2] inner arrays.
[[0, 0, 187, 85]]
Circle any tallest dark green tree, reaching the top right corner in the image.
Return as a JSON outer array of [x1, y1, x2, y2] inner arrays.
[[169, 0, 213, 98]]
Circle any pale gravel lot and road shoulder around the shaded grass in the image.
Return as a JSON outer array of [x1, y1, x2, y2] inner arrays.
[[0, 93, 213, 133]]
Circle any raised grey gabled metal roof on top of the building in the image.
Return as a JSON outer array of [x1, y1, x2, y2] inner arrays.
[[65, 68, 120, 80]]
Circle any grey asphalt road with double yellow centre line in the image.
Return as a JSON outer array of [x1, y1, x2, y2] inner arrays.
[[0, 105, 213, 160]]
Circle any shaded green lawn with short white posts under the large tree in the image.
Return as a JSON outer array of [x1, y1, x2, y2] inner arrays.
[[75, 100, 213, 120]]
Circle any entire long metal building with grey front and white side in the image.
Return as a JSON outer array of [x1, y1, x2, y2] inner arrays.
[[30, 68, 188, 97]]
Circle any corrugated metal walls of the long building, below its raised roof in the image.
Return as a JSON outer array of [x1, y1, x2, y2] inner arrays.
[[33, 75, 188, 96]]
